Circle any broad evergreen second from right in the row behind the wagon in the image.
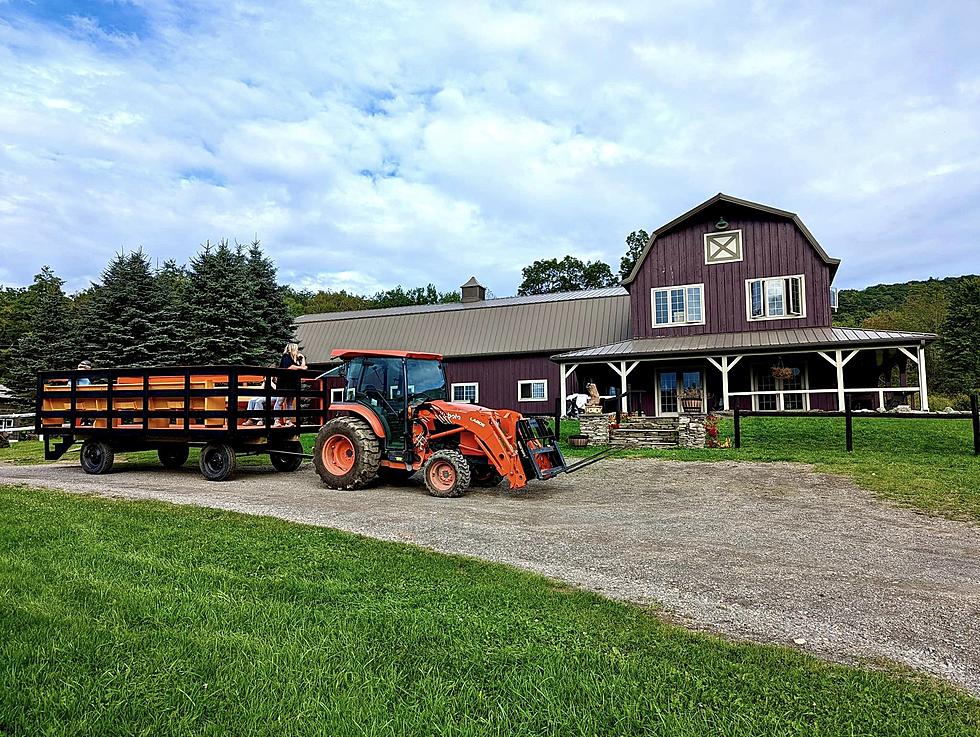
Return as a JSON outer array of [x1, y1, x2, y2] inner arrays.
[[185, 241, 260, 364]]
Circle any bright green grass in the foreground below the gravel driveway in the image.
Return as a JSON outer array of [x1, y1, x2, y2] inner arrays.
[[0, 487, 980, 735]]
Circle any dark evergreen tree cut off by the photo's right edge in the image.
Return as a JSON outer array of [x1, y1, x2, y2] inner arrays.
[[942, 276, 980, 392]]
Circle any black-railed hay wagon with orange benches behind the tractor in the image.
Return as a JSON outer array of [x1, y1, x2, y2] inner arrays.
[[35, 366, 330, 481]]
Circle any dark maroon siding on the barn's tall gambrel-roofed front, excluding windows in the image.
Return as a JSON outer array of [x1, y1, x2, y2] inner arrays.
[[629, 205, 832, 338]]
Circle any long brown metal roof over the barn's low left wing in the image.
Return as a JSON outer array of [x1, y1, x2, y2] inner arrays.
[[296, 287, 631, 363]]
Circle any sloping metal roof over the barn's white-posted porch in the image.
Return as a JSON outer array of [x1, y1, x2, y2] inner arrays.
[[551, 327, 939, 363]]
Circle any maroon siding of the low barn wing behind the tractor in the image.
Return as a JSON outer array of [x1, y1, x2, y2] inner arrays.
[[444, 353, 561, 415]]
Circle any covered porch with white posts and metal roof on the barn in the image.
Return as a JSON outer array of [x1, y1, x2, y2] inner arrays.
[[552, 328, 936, 417]]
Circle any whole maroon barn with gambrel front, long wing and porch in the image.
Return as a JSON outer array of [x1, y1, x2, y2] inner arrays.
[[297, 193, 937, 417]]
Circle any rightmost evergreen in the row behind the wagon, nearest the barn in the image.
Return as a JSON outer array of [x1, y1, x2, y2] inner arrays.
[[245, 240, 295, 365]]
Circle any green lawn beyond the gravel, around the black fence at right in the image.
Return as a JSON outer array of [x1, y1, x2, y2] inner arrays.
[[562, 415, 980, 520]]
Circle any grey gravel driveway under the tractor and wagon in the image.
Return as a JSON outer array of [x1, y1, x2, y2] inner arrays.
[[0, 459, 980, 695]]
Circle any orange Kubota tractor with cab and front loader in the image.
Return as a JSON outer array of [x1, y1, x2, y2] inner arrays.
[[313, 350, 598, 497]]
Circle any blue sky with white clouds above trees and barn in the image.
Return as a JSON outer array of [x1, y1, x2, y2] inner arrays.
[[0, 0, 980, 296]]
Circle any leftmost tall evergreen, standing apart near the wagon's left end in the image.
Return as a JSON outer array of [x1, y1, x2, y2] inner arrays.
[[7, 266, 77, 409]]
